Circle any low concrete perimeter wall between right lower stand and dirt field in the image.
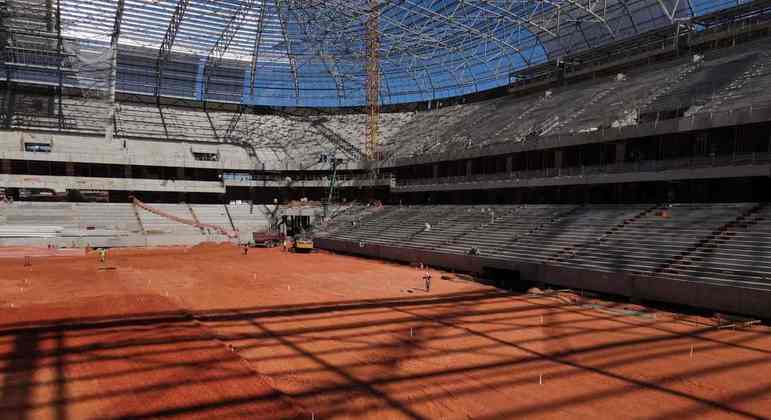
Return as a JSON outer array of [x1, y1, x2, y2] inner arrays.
[[316, 238, 771, 319]]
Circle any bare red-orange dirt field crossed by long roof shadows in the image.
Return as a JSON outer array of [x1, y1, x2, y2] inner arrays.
[[0, 245, 771, 419]]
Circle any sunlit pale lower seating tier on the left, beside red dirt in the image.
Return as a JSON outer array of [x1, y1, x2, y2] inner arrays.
[[0, 201, 271, 247]]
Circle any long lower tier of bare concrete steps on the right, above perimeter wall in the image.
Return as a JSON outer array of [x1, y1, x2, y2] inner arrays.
[[323, 203, 771, 289]]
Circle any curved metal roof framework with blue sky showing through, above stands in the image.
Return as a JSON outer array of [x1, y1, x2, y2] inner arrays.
[[0, 0, 743, 106]]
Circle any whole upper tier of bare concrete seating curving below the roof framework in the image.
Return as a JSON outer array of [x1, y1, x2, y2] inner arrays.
[[3, 38, 771, 165]]
